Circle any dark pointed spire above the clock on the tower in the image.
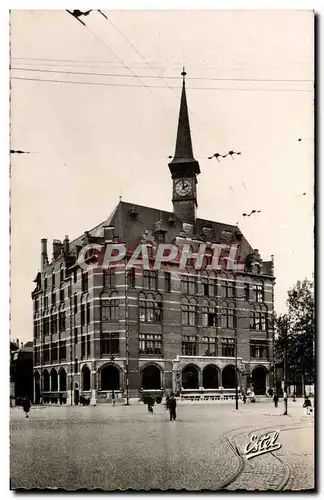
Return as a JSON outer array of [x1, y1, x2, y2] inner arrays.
[[171, 68, 196, 164]]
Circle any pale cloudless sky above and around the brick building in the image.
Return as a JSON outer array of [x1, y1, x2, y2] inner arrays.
[[11, 10, 314, 341]]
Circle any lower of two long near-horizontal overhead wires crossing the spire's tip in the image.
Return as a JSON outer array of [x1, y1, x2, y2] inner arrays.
[[11, 76, 312, 92]]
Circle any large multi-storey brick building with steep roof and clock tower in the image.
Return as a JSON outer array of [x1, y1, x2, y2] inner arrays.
[[32, 73, 274, 404]]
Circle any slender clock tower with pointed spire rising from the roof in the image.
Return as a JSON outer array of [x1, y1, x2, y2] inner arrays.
[[169, 68, 200, 225]]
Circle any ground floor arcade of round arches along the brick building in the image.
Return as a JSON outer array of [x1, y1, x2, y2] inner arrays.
[[34, 356, 272, 404]]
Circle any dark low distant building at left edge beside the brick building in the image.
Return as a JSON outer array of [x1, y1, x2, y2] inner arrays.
[[10, 340, 33, 401]]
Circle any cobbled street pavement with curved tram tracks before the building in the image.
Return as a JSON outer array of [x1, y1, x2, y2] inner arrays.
[[10, 400, 315, 491]]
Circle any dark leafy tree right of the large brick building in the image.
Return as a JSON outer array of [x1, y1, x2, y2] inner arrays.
[[275, 279, 315, 385]]
